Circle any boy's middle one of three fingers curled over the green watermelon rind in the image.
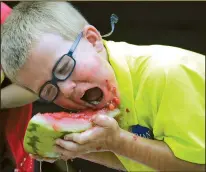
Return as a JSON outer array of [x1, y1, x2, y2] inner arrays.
[[56, 139, 79, 152]]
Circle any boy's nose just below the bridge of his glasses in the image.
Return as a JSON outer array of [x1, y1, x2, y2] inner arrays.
[[58, 80, 76, 98]]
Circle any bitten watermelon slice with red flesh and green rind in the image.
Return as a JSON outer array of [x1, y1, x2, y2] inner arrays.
[[24, 108, 120, 158]]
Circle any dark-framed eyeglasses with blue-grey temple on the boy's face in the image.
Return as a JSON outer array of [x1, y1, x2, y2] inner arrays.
[[39, 32, 83, 102]]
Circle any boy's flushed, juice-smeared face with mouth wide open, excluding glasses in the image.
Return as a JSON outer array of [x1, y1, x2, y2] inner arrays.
[[17, 26, 118, 110]]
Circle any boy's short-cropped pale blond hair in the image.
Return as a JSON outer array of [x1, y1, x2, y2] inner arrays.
[[1, 1, 88, 82]]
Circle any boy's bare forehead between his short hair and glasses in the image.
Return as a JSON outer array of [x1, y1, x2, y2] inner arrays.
[[18, 34, 72, 91]]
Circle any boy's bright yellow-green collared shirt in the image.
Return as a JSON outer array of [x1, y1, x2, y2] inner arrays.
[[104, 41, 205, 171]]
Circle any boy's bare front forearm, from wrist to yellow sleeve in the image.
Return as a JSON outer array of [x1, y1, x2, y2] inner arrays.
[[109, 130, 205, 171]]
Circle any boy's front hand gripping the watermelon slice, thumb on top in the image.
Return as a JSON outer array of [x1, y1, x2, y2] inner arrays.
[[56, 115, 120, 160]]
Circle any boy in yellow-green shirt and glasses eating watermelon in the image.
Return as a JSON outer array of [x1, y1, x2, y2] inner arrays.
[[2, 2, 205, 171]]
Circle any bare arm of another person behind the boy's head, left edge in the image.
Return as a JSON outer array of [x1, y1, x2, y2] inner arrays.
[[1, 84, 38, 109]]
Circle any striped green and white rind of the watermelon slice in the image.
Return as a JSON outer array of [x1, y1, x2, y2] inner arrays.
[[23, 109, 120, 158]]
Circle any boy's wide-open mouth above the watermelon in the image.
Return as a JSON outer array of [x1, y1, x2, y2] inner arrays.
[[81, 87, 103, 105]]
